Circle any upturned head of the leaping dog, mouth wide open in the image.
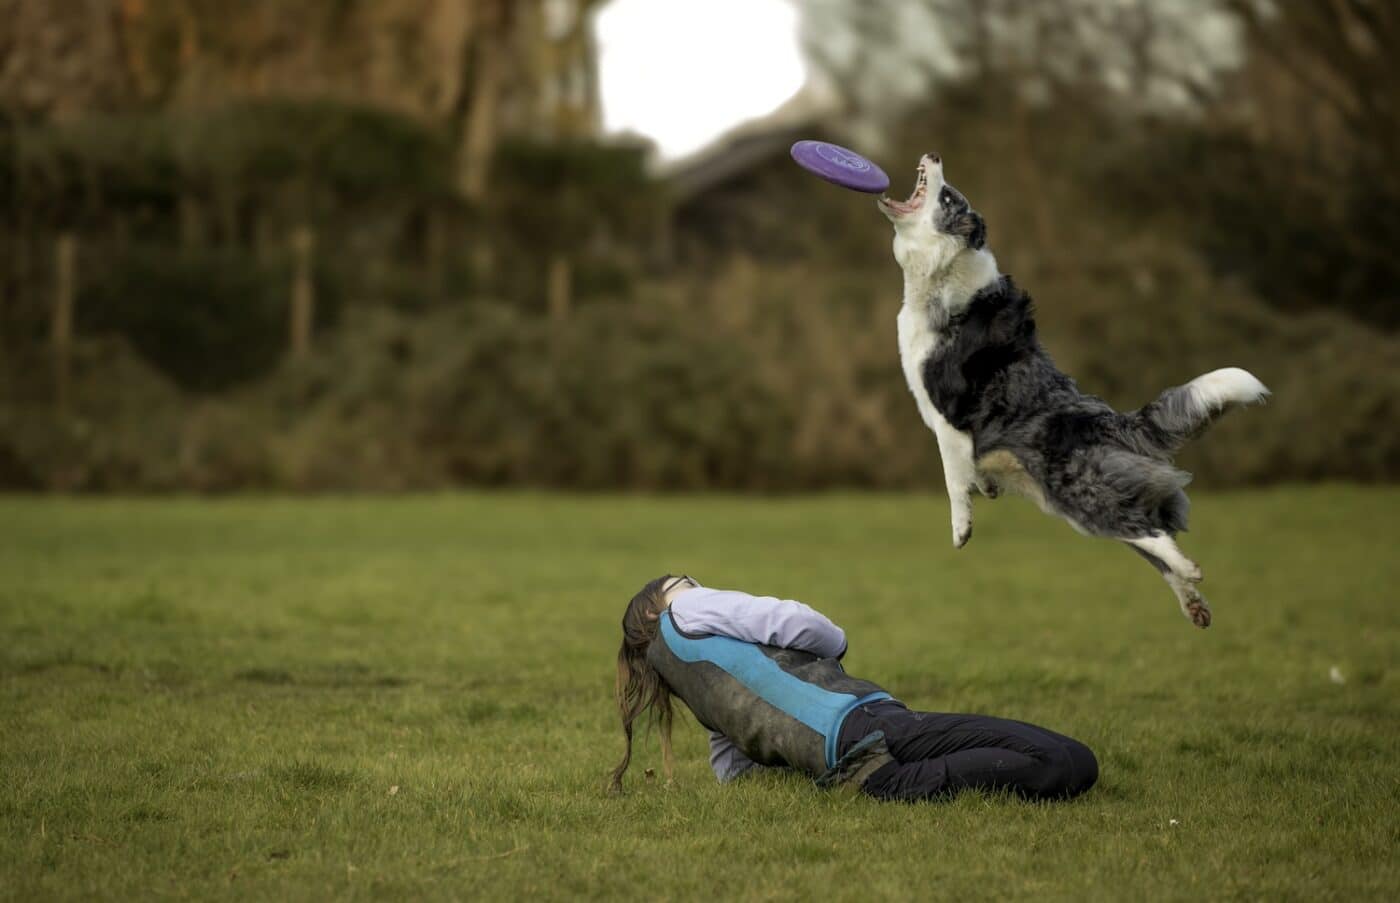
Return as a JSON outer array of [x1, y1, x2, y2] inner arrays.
[[876, 154, 987, 272]]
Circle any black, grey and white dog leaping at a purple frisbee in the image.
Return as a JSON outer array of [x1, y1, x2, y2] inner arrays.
[[878, 154, 1268, 627]]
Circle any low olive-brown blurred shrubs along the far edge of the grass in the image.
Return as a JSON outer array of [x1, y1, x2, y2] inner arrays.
[[0, 253, 1400, 491]]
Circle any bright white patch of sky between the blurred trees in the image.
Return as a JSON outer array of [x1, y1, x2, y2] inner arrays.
[[596, 0, 806, 158]]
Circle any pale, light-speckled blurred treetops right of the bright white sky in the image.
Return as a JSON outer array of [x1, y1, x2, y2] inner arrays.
[[799, 0, 1239, 140]]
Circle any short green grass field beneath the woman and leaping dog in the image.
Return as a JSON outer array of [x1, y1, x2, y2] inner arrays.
[[0, 487, 1400, 900]]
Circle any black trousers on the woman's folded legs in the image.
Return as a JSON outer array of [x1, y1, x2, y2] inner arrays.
[[839, 700, 1099, 799]]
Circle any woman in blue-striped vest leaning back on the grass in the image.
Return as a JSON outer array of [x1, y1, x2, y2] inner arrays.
[[613, 574, 1099, 799]]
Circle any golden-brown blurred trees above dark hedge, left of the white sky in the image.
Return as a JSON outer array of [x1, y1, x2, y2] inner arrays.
[[0, 0, 601, 202]]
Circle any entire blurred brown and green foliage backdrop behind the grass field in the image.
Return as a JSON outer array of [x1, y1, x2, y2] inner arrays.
[[0, 0, 1400, 491]]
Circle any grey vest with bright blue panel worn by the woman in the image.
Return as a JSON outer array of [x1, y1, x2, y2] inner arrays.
[[647, 612, 890, 777]]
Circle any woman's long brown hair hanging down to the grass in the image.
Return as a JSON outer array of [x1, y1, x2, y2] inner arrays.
[[612, 574, 673, 792]]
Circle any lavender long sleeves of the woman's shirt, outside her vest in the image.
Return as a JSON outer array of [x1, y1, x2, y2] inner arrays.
[[671, 587, 846, 783]]
